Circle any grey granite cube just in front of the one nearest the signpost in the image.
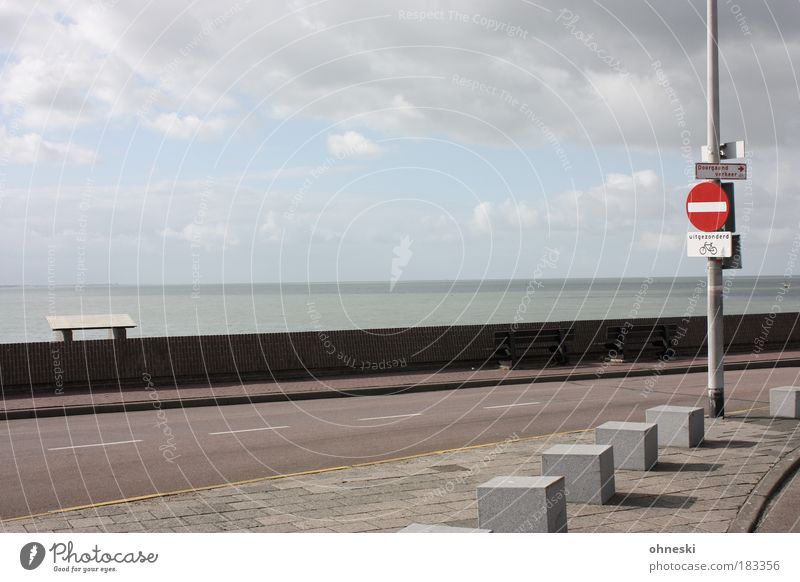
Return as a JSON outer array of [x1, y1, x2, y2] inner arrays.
[[594, 422, 658, 471]]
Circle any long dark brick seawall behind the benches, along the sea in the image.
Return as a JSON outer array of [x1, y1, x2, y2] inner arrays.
[[0, 313, 800, 391]]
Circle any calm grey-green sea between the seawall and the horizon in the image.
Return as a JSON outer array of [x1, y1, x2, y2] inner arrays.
[[0, 275, 800, 343]]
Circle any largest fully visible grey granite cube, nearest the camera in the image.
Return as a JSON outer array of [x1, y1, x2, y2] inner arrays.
[[478, 476, 567, 533]]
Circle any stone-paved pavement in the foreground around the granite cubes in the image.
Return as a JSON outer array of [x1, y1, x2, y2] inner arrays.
[[0, 416, 800, 532]]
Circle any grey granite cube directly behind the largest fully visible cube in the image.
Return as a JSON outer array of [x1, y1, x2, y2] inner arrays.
[[542, 445, 615, 504]]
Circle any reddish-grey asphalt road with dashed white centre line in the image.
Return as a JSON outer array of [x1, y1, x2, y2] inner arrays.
[[0, 368, 800, 519]]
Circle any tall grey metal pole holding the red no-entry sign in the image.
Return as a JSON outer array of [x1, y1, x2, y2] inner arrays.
[[706, 0, 725, 418]]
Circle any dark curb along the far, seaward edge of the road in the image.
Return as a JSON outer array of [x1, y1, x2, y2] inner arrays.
[[0, 358, 800, 421]]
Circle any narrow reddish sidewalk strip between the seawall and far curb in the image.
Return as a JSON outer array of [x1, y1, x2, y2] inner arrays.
[[0, 351, 800, 420]]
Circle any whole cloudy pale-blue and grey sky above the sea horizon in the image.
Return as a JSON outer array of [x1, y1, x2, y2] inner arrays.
[[0, 0, 800, 285]]
